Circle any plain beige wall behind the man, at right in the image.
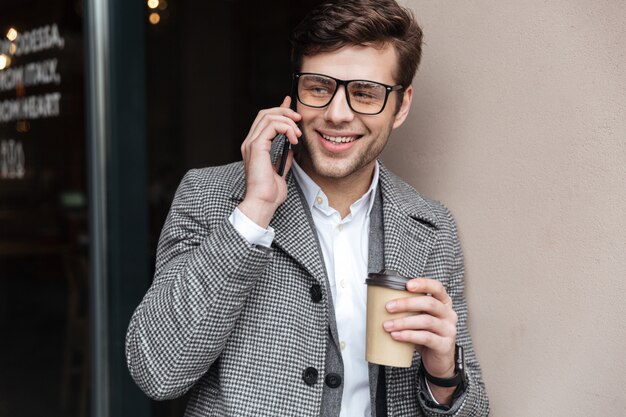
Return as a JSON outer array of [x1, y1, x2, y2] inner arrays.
[[383, 0, 626, 417]]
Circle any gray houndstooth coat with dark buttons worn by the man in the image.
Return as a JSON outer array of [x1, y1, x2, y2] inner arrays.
[[126, 158, 489, 417]]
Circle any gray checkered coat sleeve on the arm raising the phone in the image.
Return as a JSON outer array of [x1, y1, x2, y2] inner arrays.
[[126, 170, 271, 400]]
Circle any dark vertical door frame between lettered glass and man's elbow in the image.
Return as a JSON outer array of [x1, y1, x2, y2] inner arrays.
[[83, 0, 150, 417]]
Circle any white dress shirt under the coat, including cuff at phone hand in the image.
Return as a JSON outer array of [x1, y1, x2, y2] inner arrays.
[[230, 161, 379, 417]]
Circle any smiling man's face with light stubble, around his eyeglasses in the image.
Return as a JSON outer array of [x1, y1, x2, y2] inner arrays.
[[298, 44, 412, 185]]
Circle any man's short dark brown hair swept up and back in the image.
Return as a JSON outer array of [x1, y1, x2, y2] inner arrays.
[[291, 0, 422, 87]]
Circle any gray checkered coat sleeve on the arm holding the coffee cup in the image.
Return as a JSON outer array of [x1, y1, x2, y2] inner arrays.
[[419, 209, 489, 417]]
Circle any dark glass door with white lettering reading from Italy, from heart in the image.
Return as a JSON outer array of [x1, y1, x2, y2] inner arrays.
[[0, 0, 89, 417]]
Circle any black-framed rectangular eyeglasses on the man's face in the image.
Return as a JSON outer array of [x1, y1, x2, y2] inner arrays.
[[293, 72, 404, 115]]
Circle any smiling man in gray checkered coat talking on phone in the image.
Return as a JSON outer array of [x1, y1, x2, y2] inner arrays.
[[127, 0, 488, 417]]
